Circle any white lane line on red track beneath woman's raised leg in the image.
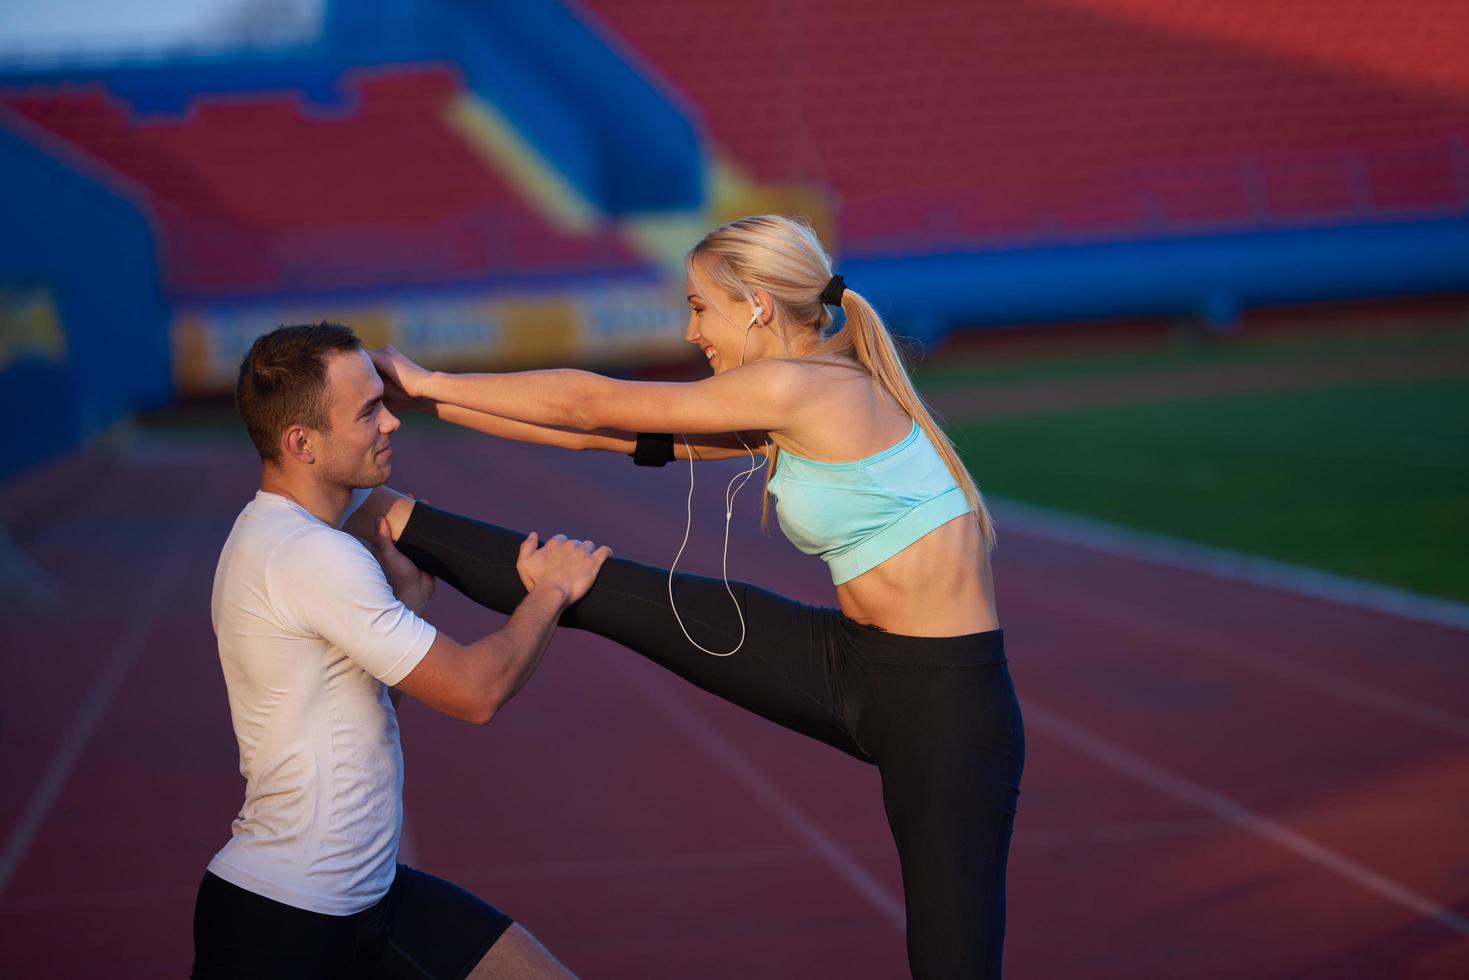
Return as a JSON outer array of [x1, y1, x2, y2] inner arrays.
[[607, 655, 906, 932]]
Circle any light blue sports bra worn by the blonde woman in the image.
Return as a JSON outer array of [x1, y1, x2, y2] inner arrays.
[[770, 422, 970, 585]]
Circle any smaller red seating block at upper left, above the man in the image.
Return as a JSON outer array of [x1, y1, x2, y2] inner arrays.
[[0, 65, 643, 298]]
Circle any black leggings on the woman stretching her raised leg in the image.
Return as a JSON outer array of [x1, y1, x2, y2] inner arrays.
[[398, 504, 1025, 979]]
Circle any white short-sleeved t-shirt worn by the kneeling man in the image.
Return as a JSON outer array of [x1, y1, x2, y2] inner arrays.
[[209, 491, 435, 915]]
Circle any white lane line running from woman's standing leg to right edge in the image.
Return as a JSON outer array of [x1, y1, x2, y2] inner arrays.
[[1024, 699, 1469, 936]]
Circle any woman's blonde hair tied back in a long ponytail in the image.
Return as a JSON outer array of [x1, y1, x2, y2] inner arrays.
[[687, 215, 995, 551]]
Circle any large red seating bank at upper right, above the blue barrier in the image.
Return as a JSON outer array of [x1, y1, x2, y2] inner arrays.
[[582, 0, 1469, 254]]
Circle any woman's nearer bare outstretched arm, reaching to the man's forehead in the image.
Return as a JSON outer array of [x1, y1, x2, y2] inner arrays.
[[372, 347, 806, 433]]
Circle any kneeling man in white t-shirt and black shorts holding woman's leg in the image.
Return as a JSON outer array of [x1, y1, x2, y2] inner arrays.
[[194, 323, 610, 980]]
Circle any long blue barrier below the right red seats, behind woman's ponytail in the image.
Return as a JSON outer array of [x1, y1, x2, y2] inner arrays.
[[843, 217, 1469, 342]]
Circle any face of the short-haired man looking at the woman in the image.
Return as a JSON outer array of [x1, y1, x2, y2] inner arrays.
[[316, 351, 401, 489]]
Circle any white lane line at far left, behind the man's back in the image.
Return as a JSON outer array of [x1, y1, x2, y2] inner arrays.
[[0, 533, 197, 896]]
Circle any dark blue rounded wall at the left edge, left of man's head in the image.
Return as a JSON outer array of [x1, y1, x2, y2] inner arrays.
[[0, 126, 170, 478]]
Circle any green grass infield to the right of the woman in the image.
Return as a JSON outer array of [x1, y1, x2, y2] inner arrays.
[[949, 372, 1469, 601]]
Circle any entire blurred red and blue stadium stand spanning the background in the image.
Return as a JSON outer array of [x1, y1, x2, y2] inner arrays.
[[0, 0, 1469, 476]]
